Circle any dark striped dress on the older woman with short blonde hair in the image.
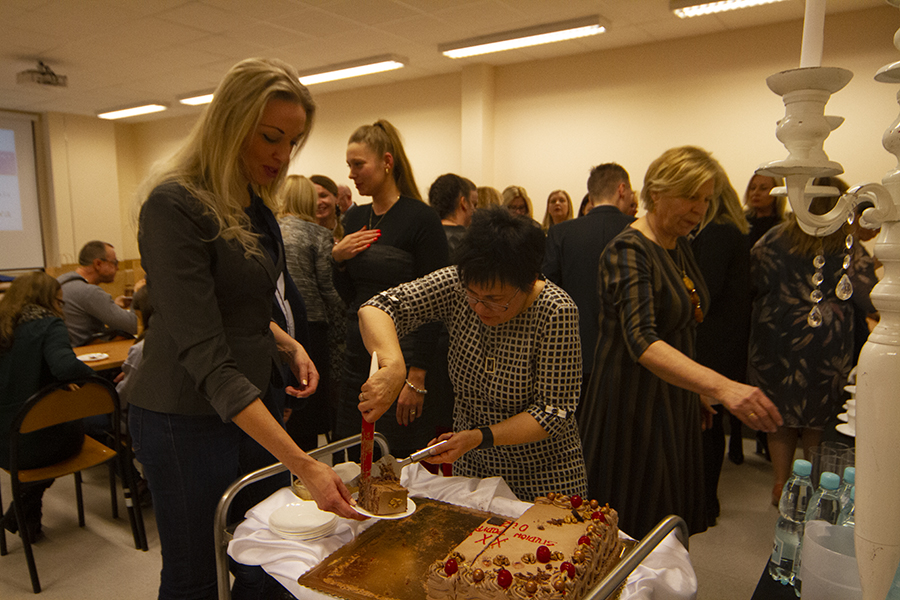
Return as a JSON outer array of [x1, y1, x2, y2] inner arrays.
[[578, 228, 709, 537]]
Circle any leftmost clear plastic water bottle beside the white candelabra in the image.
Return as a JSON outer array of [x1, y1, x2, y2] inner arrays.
[[769, 460, 812, 585]]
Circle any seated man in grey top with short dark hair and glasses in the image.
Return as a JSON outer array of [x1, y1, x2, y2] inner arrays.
[[58, 241, 144, 346]]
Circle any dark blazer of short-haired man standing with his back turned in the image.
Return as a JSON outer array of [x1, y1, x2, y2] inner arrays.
[[543, 205, 634, 370]]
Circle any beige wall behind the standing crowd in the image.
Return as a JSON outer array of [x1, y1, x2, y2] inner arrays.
[[40, 7, 900, 262]]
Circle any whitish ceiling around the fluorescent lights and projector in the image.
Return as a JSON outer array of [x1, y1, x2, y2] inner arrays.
[[0, 0, 885, 122]]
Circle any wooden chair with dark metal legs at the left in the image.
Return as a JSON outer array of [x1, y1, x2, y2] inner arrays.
[[0, 377, 147, 594]]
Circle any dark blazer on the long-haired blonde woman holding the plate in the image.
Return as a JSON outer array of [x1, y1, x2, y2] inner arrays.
[[129, 182, 284, 421]]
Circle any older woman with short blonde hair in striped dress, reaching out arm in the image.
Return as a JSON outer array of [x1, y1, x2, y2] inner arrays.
[[578, 146, 781, 537]]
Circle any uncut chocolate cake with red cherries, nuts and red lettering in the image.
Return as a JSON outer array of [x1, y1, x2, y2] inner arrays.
[[425, 494, 621, 600]]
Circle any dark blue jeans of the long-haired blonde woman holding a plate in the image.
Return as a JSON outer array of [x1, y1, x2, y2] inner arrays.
[[128, 405, 290, 600]]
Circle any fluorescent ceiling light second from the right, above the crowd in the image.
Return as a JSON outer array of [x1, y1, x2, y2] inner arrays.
[[438, 15, 606, 58]]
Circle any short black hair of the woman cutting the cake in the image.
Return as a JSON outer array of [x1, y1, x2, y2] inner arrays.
[[456, 206, 547, 291]]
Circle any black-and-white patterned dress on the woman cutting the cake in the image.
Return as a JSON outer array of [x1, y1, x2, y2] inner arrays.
[[366, 267, 587, 502]]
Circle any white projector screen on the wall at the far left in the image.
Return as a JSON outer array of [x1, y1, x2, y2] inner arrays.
[[0, 112, 44, 271]]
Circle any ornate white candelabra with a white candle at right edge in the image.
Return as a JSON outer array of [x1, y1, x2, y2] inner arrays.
[[760, 0, 900, 600]]
